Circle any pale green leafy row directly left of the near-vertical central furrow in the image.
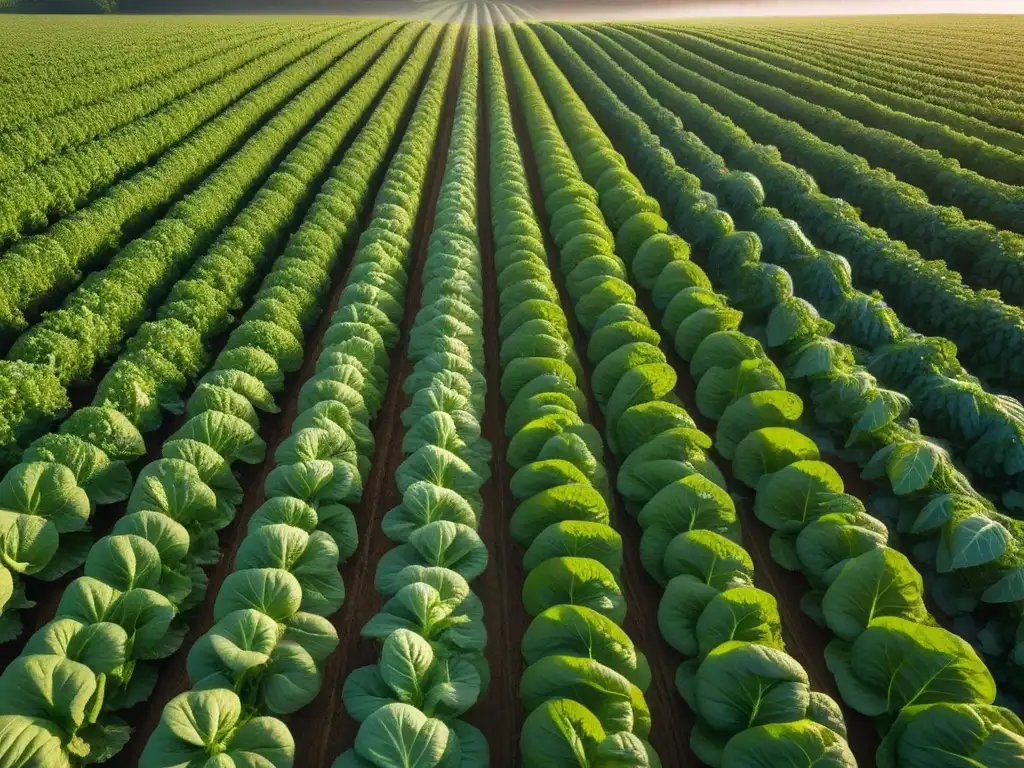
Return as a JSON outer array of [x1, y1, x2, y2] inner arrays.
[[334, 31, 490, 768]]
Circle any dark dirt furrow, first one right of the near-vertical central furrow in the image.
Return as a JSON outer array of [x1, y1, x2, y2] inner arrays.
[[505, 36, 699, 765]]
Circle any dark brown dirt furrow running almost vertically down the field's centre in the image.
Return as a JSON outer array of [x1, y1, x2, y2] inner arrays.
[[466, 20, 529, 766]]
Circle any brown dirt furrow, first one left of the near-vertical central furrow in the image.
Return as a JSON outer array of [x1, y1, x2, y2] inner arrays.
[[288, 27, 465, 768]]
